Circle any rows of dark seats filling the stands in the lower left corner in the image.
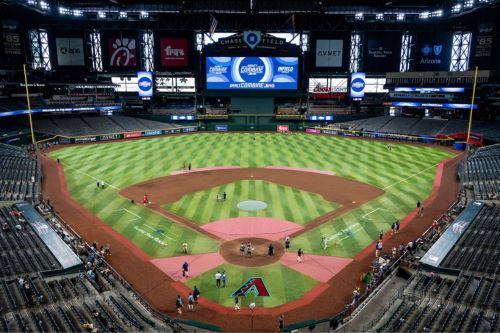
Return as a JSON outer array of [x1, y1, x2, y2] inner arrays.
[[0, 205, 182, 332]]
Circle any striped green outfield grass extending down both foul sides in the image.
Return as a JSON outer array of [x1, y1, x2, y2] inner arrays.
[[50, 133, 453, 257]]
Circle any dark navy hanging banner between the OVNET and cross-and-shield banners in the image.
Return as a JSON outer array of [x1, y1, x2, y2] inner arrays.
[[363, 34, 401, 72]]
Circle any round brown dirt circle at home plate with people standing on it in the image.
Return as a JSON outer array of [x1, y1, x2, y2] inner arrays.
[[219, 238, 285, 267]]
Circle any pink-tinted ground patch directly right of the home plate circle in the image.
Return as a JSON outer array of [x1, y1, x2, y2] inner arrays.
[[280, 252, 352, 282]]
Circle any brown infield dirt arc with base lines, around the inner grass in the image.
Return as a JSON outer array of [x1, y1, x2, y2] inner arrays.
[[120, 168, 384, 238]]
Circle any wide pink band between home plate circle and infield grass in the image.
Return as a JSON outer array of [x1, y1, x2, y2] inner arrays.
[[201, 217, 304, 241]]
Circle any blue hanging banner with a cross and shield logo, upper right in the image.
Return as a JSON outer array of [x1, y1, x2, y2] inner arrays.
[[415, 33, 451, 71]]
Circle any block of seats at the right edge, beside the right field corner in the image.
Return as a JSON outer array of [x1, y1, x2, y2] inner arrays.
[[461, 144, 500, 201]]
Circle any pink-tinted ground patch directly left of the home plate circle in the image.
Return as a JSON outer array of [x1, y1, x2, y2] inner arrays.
[[151, 253, 225, 281]]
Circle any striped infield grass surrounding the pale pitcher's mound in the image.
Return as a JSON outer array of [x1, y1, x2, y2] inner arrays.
[[164, 180, 340, 224]]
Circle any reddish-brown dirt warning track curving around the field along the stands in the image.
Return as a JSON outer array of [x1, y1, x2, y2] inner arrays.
[[42, 148, 460, 331]]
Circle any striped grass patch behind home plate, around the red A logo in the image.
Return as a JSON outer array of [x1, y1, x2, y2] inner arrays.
[[186, 259, 318, 308]]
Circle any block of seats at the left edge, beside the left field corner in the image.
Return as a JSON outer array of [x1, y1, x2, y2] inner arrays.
[[0, 144, 40, 202]]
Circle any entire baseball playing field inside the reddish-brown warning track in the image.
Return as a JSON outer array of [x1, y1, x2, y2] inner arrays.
[[49, 133, 454, 307]]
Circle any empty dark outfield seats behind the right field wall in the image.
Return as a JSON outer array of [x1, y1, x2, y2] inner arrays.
[[335, 116, 500, 141]]
